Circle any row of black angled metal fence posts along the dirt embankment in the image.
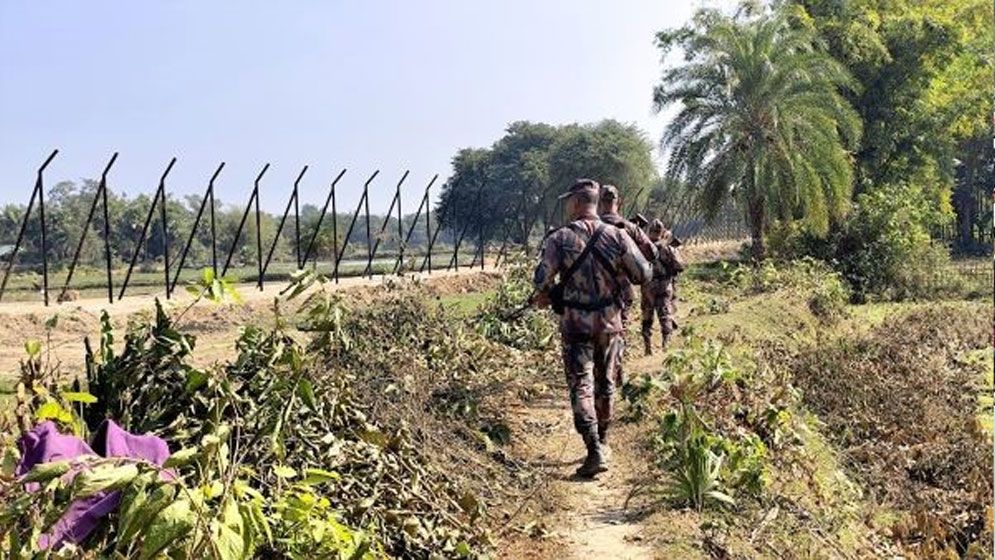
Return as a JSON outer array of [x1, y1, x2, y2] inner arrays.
[[0, 150, 746, 306]]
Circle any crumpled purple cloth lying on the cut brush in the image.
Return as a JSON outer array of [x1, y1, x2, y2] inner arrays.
[[16, 420, 169, 549]]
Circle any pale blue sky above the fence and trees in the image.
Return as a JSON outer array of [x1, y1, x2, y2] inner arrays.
[[0, 0, 701, 211]]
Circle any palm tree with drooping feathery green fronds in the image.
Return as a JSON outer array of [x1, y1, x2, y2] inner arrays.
[[653, 6, 861, 260]]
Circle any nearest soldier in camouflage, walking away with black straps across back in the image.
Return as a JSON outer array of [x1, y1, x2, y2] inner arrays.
[[534, 179, 650, 478]]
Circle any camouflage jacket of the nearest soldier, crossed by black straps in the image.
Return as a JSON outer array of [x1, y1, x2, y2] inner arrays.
[[533, 216, 652, 335]]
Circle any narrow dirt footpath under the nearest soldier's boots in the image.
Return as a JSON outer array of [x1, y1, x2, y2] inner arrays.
[[500, 352, 657, 560]]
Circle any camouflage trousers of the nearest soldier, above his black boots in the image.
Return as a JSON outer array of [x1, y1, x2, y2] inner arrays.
[[563, 333, 622, 436]]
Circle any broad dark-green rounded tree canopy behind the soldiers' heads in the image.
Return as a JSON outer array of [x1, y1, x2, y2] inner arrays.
[[436, 120, 657, 248]]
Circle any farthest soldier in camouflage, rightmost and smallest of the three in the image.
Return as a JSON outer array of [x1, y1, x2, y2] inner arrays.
[[642, 220, 684, 356]]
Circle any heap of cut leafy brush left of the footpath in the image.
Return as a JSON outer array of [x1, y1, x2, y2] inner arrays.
[[0, 274, 552, 559]]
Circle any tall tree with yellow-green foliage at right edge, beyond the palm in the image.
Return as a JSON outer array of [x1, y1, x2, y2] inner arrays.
[[789, 0, 995, 249]]
